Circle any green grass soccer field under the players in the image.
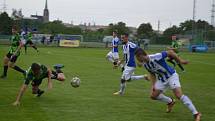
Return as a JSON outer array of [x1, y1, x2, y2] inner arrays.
[[0, 46, 215, 121]]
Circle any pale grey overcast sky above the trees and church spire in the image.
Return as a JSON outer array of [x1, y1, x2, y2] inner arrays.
[[0, 0, 212, 29]]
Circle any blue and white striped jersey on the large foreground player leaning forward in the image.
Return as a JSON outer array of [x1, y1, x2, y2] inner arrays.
[[143, 51, 176, 82]]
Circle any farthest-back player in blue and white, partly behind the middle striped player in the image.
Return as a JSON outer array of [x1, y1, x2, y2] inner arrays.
[[106, 31, 119, 67]]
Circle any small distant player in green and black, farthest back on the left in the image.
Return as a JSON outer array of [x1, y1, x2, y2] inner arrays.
[[24, 31, 39, 54]]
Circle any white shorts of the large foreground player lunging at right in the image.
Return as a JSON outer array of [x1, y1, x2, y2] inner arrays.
[[155, 73, 181, 91]]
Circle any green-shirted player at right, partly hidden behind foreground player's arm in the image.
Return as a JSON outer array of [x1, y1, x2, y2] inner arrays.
[[167, 36, 185, 72]]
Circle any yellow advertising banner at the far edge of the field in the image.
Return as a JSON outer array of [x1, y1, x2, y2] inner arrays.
[[60, 40, 80, 47]]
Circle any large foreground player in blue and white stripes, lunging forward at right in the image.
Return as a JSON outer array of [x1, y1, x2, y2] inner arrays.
[[135, 48, 201, 121]]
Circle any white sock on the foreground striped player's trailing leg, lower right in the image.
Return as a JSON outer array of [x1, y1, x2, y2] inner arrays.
[[180, 95, 198, 115]]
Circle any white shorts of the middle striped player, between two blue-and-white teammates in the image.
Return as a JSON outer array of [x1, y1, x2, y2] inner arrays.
[[121, 66, 135, 81]]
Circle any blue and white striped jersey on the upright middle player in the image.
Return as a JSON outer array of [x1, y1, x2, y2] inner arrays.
[[123, 42, 137, 67]]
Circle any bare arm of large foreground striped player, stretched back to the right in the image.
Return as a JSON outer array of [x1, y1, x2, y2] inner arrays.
[[167, 50, 189, 64]]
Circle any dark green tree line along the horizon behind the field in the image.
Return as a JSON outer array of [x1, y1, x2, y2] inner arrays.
[[0, 11, 215, 44]]
